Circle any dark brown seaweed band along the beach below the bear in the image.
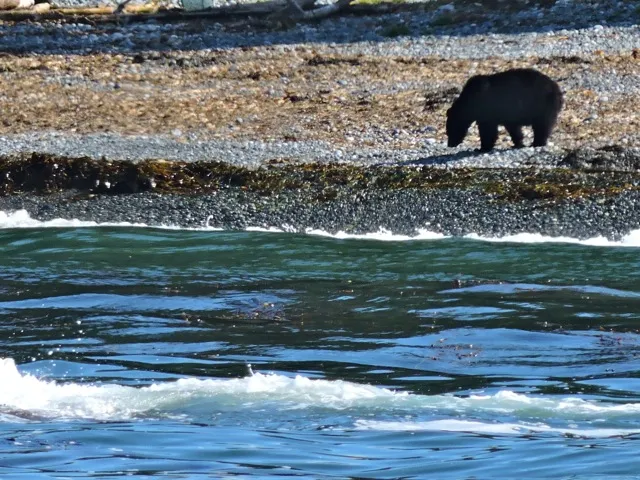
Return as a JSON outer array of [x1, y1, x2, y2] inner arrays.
[[0, 148, 640, 203]]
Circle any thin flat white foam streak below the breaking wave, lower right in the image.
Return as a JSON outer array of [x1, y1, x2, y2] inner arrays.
[[355, 419, 640, 438]]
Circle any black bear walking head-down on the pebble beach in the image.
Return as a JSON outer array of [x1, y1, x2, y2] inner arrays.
[[447, 68, 563, 152]]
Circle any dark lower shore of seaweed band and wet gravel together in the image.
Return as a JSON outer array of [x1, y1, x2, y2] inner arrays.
[[0, 150, 640, 240]]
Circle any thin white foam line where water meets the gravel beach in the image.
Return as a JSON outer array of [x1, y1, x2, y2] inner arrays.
[[0, 210, 640, 247]]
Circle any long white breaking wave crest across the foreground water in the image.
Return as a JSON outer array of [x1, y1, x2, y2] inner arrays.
[[0, 358, 640, 430]]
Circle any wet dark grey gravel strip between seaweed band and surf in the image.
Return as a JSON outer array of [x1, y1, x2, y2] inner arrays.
[[0, 183, 640, 240]]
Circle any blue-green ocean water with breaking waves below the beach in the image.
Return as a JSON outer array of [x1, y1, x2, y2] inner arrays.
[[0, 212, 640, 480]]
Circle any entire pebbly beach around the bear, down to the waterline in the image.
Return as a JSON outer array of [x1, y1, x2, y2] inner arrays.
[[0, 0, 640, 239]]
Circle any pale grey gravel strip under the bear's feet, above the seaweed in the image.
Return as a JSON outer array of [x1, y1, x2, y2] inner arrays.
[[0, 133, 564, 168]]
